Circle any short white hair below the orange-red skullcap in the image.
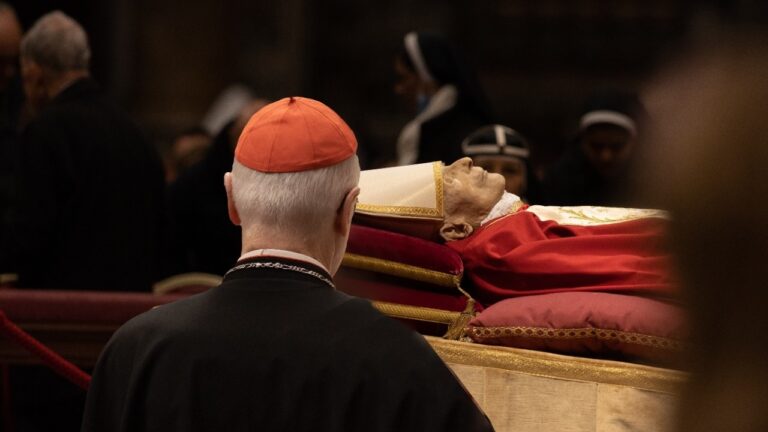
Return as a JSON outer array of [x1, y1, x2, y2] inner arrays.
[[232, 155, 360, 237]]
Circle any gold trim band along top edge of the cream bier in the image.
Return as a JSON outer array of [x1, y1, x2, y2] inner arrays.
[[425, 336, 687, 394]]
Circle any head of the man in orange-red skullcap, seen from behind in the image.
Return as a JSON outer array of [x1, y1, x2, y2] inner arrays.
[[224, 98, 360, 273]]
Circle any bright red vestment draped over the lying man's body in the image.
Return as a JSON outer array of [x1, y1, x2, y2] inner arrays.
[[447, 211, 674, 303]]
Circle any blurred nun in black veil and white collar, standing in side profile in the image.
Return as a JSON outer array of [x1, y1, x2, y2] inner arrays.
[[395, 32, 492, 165]]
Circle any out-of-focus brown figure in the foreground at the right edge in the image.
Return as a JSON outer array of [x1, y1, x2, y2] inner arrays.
[[644, 27, 768, 432]]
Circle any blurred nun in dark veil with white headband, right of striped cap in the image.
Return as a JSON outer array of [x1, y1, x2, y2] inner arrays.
[[542, 90, 643, 207]]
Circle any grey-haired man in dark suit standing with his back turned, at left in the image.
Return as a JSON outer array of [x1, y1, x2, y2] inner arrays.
[[9, 12, 163, 291]]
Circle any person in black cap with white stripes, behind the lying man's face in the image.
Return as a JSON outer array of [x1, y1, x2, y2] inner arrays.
[[461, 124, 539, 202]]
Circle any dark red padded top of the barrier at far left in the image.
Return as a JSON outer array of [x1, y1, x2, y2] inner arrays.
[[0, 289, 181, 325]]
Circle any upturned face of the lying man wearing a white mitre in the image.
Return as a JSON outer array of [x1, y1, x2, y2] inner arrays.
[[443, 158, 505, 226]]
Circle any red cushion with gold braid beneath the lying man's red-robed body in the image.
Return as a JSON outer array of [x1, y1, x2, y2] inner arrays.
[[469, 292, 685, 364]]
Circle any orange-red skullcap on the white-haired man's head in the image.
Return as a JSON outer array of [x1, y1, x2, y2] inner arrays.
[[235, 97, 357, 173]]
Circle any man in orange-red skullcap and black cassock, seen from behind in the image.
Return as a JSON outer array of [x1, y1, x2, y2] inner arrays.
[[83, 97, 493, 432]]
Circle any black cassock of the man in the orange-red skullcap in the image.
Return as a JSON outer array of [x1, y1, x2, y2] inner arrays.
[[83, 257, 493, 432]]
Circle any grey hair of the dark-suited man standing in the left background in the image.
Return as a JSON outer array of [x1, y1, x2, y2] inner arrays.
[[21, 11, 91, 73]]
